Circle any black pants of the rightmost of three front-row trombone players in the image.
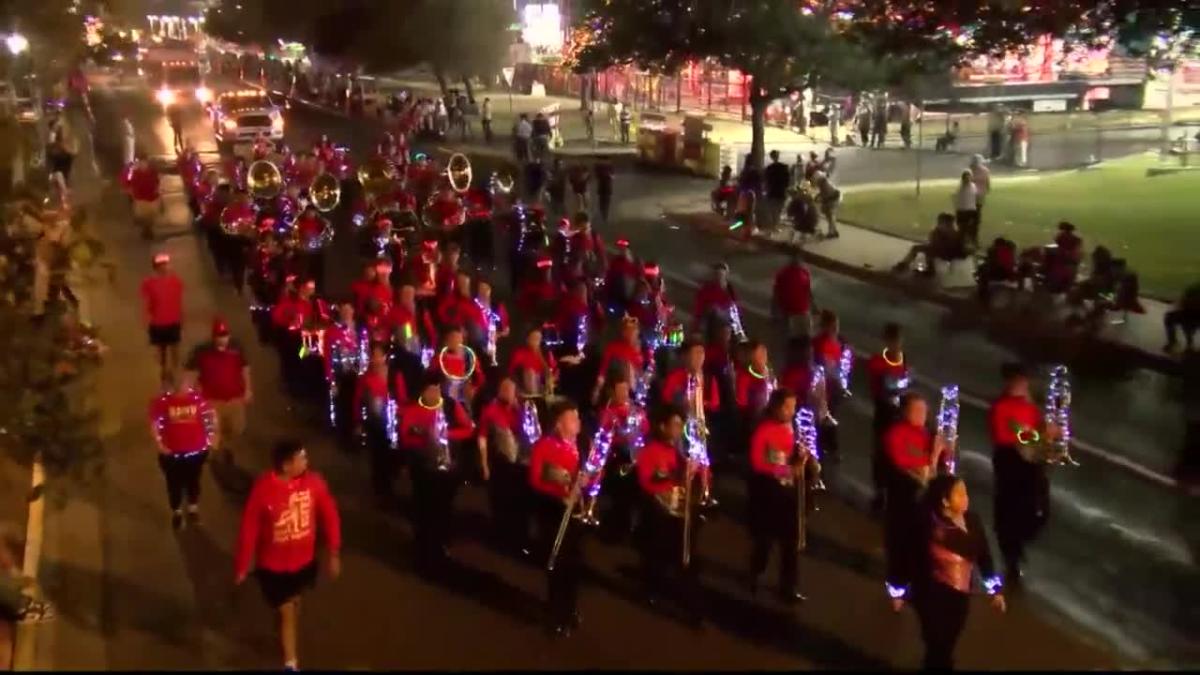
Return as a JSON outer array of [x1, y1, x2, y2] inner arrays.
[[749, 473, 799, 595]]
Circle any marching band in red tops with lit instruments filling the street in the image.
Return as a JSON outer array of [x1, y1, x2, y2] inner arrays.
[[150, 130, 1070, 648]]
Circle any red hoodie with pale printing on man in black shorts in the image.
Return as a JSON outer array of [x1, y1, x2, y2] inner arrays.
[[234, 471, 342, 578]]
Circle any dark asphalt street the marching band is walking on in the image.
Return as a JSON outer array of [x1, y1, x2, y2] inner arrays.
[[32, 79, 1200, 669]]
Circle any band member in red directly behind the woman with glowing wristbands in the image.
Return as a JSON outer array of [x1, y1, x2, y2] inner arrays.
[[883, 392, 946, 598]]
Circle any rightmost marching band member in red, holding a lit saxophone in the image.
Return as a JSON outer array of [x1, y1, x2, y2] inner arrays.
[[989, 364, 1061, 585]]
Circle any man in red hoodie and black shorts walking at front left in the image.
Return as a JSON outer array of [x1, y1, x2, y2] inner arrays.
[[234, 441, 342, 670]]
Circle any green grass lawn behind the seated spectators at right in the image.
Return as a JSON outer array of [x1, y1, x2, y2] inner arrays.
[[841, 156, 1200, 300]]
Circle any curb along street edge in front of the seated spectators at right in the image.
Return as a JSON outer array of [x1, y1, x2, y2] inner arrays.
[[664, 211, 1183, 376]]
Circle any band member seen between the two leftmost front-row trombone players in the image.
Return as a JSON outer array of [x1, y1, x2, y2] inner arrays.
[[596, 374, 649, 540]]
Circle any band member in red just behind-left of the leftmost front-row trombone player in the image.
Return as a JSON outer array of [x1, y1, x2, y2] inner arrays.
[[476, 377, 540, 555]]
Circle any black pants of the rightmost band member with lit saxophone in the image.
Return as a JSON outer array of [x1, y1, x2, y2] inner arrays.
[[991, 446, 1050, 568]]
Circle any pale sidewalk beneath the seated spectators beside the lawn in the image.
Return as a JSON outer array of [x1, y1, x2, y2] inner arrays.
[[666, 201, 1181, 374]]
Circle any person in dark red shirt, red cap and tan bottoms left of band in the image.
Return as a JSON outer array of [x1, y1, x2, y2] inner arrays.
[[185, 317, 251, 464]]
